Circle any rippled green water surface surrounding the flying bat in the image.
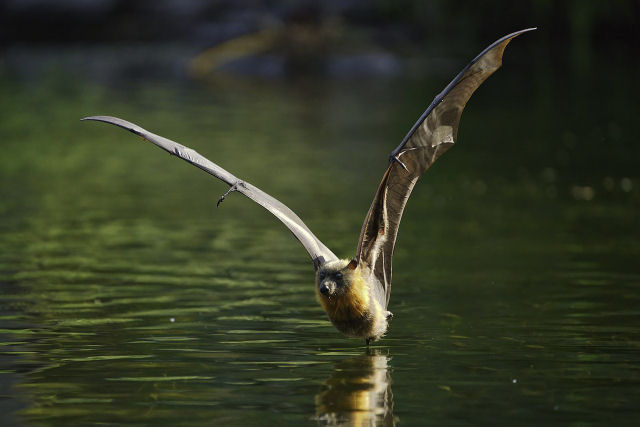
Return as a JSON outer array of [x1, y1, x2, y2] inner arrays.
[[0, 45, 640, 425]]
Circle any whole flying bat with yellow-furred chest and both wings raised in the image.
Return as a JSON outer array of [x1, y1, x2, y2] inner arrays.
[[84, 28, 534, 344]]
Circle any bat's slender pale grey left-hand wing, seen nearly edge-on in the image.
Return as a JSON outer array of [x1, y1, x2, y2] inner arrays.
[[83, 116, 338, 268]]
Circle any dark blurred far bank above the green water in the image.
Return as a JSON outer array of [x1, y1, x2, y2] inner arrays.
[[0, 0, 640, 76]]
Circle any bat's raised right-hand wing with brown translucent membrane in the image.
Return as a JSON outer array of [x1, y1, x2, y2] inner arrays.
[[356, 28, 535, 308]]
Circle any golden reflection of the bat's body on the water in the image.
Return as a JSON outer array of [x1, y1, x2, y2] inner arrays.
[[316, 353, 395, 426]]
